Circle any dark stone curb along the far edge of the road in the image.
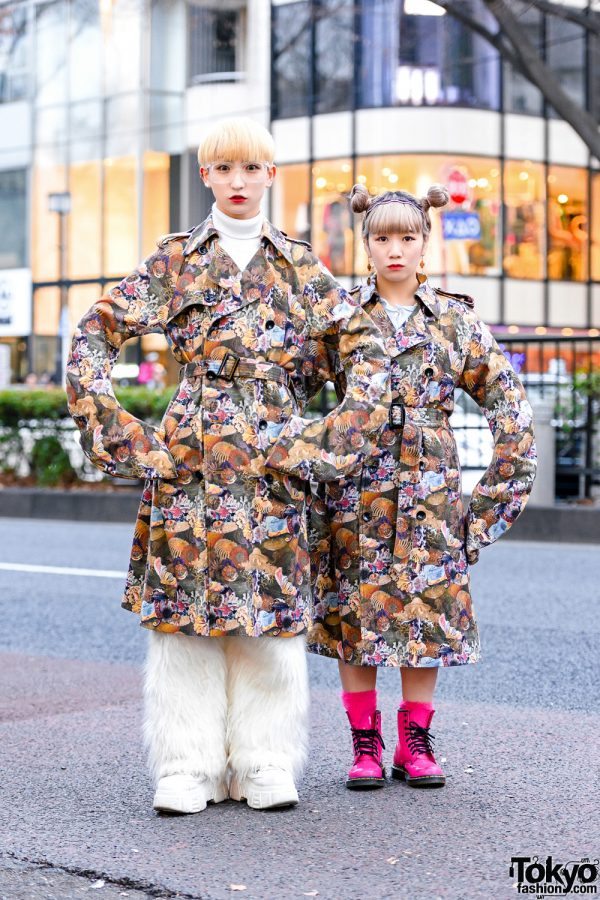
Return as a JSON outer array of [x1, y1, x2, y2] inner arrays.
[[0, 485, 600, 544]]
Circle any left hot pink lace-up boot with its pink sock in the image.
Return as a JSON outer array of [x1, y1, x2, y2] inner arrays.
[[342, 691, 385, 790]]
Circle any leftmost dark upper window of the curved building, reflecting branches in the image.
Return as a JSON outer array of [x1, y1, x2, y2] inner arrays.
[[271, 0, 312, 119]]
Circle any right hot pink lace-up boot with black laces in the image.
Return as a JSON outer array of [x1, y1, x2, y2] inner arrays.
[[392, 700, 446, 787]]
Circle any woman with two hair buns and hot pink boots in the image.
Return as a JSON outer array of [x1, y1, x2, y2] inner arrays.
[[308, 185, 536, 788]]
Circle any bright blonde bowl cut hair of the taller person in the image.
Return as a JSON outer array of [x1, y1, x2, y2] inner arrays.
[[198, 116, 275, 168]]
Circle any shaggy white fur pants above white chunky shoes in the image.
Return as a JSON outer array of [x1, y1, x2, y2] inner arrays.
[[144, 632, 309, 781]]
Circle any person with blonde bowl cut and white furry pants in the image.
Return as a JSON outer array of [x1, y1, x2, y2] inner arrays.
[[68, 119, 389, 813]]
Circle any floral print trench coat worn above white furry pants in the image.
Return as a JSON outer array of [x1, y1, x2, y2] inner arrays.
[[67, 217, 389, 637]]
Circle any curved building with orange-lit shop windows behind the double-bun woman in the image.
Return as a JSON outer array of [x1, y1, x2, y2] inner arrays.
[[272, 0, 600, 331]]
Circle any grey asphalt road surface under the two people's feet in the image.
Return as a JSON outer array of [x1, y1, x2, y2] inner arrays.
[[0, 520, 600, 900]]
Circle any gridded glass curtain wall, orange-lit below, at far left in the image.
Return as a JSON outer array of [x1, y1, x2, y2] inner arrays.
[[0, 0, 185, 379]]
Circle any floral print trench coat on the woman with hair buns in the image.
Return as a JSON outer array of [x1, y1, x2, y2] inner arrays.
[[308, 279, 536, 667]]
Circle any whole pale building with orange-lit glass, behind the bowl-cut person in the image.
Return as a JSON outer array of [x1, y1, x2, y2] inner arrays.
[[0, 0, 270, 381]]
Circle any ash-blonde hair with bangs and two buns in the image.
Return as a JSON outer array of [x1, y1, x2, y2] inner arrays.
[[350, 184, 450, 241]]
